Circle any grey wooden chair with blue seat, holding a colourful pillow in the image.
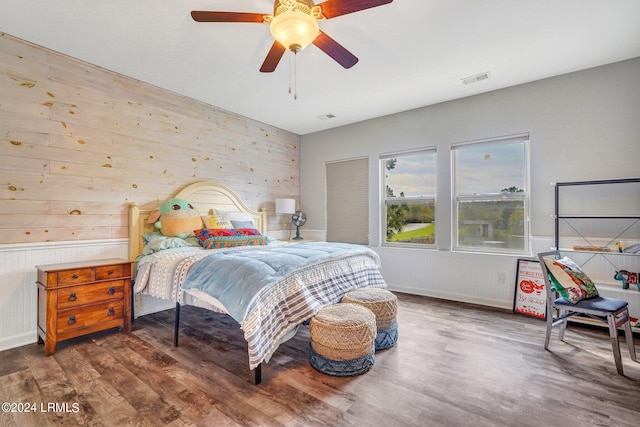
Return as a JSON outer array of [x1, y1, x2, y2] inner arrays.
[[538, 251, 636, 375]]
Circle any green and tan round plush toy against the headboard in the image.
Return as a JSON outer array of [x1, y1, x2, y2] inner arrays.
[[147, 197, 202, 239]]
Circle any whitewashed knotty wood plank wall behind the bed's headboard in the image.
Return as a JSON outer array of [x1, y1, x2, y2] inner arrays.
[[0, 33, 300, 244]]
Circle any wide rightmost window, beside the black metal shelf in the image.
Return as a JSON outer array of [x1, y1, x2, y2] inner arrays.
[[452, 135, 529, 253]]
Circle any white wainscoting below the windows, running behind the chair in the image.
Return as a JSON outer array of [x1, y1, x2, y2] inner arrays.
[[373, 236, 640, 324]]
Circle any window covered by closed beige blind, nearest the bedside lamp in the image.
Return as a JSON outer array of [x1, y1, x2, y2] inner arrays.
[[326, 158, 369, 245]]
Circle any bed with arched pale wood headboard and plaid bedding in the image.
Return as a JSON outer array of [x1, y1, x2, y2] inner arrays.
[[129, 181, 386, 384]]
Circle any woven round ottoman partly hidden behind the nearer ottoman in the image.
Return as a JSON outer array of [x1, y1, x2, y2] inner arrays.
[[342, 288, 398, 350]]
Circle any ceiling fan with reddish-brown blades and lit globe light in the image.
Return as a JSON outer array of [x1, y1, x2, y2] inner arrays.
[[191, 0, 393, 73]]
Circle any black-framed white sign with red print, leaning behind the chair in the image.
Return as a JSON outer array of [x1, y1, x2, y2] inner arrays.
[[513, 259, 547, 319]]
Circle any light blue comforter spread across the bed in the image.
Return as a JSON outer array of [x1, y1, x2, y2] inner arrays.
[[182, 242, 379, 323]]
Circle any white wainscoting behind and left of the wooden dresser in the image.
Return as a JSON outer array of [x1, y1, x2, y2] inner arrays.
[[0, 239, 129, 351]]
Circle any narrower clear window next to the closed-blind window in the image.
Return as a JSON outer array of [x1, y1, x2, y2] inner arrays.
[[380, 148, 436, 247]]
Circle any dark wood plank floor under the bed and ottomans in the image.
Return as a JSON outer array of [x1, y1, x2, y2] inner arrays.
[[0, 294, 640, 427]]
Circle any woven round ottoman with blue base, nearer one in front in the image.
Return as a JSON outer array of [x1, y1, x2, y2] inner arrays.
[[309, 304, 376, 377]]
